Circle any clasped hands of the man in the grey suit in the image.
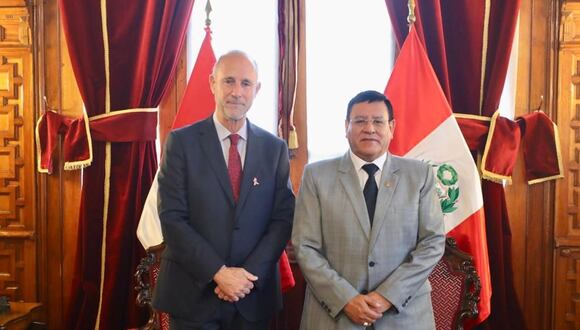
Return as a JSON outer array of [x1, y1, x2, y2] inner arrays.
[[343, 291, 392, 327]]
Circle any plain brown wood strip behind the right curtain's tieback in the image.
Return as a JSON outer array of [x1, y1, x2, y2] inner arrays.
[[506, 0, 559, 330]]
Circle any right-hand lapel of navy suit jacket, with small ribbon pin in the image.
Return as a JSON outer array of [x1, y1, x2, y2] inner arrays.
[[236, 121, 264, 218]]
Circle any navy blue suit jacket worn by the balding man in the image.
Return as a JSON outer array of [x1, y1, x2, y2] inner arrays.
[[153, 117, 294, 321]]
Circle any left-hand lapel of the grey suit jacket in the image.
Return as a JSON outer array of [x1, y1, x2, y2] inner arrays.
[[338, 152, 371, 239]]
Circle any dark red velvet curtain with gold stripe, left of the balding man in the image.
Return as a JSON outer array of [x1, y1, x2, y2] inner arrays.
[[59, 0, 194, 329]]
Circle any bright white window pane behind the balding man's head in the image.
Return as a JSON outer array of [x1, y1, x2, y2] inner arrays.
[[187, 0, 278, 134]]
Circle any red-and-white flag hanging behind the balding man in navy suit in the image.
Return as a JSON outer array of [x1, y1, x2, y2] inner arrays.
[[137, 27, 296, 292]]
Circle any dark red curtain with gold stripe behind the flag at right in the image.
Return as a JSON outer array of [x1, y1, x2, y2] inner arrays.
[[385, 0, 525, 329]]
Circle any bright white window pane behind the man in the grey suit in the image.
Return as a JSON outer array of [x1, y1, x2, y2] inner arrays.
[[305, 0, 395, 162]]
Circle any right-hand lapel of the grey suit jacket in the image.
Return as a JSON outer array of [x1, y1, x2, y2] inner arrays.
[[370, 154, 399, 249]]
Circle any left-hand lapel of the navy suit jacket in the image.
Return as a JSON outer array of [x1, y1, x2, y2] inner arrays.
[[199, 117, 234, 206]]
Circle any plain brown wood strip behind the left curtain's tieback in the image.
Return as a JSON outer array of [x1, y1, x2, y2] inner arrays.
[[34, 0, 83, 329]]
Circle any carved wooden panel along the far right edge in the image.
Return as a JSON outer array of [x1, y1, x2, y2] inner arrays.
[[553, 2, 580, 329]]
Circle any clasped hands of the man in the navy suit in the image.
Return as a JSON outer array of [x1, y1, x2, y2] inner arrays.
[[213, 265, 258, 302]]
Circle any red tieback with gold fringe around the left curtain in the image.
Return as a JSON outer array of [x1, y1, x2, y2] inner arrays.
[[35, 108, 157, 173]]
